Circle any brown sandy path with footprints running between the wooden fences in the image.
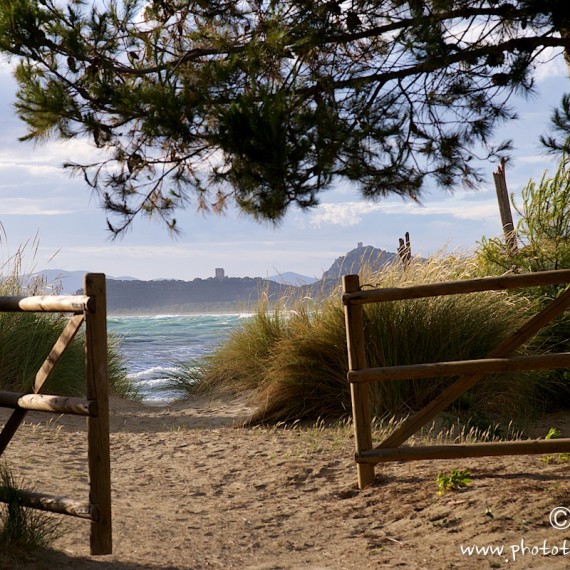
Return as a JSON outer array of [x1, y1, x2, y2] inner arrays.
[[0, 394, 570, 570]]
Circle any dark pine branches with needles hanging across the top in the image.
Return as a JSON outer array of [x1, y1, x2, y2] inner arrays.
[[0, 0, 570, 233]]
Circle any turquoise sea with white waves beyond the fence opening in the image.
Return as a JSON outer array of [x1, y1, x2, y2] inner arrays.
[[107, 313, 251, 405]]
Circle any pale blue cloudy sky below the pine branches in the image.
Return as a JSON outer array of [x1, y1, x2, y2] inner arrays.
[[0, 52, 570, 280]]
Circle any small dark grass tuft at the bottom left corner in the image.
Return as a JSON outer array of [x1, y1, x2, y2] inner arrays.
[[0, 464, 61, 553]]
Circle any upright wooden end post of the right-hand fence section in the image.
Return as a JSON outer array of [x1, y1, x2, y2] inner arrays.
[[342, 275, 374, 489]]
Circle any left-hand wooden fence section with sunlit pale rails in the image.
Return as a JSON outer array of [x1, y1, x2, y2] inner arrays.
[[0, 273, 112, 555]]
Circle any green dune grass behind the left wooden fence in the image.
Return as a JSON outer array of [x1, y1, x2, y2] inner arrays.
[[0, 247, 137, 398]]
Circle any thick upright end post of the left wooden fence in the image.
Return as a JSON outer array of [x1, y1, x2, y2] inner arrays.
[[85, 273, 112, 555]]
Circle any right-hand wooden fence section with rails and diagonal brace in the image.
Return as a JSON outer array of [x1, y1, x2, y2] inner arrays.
[[343, 270, 570, 489]]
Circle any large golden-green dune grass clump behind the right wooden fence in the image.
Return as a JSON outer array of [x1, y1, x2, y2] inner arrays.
[[171, 256, 537, 423]]
